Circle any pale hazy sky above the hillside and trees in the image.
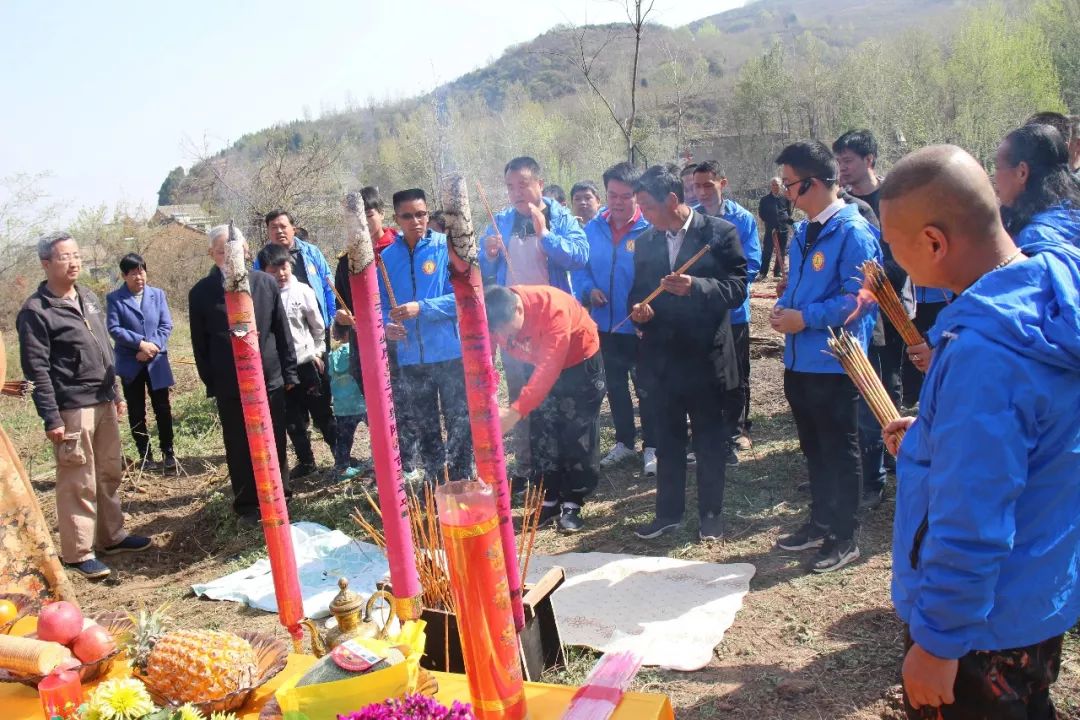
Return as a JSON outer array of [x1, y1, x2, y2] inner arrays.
[[0, 0, 743, 216]]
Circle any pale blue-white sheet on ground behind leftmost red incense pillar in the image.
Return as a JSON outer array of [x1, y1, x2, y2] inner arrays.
[[191, 522, 389, 617]]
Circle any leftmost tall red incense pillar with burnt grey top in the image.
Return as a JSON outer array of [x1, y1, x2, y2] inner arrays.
[[222, 222, 303, 644]]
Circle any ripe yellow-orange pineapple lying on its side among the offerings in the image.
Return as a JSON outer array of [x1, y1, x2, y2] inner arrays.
[[127, 607, 258, 704]]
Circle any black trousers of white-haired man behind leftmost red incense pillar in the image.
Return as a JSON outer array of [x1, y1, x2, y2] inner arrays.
[[216, 388, 292, 515]]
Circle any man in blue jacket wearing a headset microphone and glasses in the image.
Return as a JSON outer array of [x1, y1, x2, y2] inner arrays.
[[769, 142, 881, 572]]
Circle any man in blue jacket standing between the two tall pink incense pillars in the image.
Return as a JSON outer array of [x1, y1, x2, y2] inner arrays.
[[379, 188, 472, 484]]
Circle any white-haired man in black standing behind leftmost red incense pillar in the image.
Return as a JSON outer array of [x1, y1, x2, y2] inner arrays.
[[188, 225, 299, 525]]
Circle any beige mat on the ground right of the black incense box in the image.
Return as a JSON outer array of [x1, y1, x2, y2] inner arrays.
[[528, 553, 755, 670]]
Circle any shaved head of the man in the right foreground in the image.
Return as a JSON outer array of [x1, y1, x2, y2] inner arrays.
[[880, 145, 1016, 291]]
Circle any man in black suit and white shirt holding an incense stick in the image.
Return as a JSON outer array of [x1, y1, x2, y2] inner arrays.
[[630, 166, 746, 540]]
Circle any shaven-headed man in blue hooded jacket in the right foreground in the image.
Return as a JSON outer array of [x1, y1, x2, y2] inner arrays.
[[881, 146, 1080, 720]]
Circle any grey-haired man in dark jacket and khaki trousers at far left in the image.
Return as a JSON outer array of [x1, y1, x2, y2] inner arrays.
[[15, 232, 151, 579]]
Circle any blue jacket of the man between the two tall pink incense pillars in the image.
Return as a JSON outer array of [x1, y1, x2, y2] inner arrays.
[[379, 230, 461, 366]]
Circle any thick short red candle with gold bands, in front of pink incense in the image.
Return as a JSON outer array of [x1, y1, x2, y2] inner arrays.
[[435, 480, 528, 720]]
